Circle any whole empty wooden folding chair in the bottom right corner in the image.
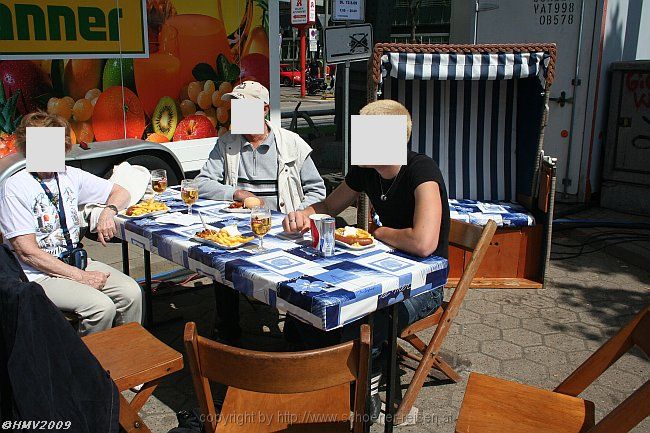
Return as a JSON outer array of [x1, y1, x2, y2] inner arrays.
[[456, 305, 650, 433]]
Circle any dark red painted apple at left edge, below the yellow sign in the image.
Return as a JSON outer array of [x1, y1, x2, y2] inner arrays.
[[0, 60, 52, 114]]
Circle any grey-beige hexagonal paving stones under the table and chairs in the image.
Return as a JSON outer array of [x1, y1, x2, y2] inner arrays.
[[92, 218, 650, 433]]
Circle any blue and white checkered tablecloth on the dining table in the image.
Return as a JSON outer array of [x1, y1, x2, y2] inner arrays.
[[116, 190, 447, 330]]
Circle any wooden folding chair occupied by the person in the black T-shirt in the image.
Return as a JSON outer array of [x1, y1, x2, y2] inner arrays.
[[395, 220, 497, 420]]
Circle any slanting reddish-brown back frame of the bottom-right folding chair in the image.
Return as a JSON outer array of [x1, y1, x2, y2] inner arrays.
[[554, 305, 650, 433]]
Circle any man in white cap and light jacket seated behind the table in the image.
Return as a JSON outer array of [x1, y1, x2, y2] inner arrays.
[[196, 81, 325, 343]]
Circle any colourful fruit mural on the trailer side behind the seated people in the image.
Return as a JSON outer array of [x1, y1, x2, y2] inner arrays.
[[0, 0, 270, 157]]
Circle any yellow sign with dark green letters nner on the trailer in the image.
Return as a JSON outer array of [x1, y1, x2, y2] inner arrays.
[[0, 0, 148, 59]]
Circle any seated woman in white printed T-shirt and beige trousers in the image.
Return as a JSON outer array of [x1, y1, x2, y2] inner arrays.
[[0, 112, 142, 335]]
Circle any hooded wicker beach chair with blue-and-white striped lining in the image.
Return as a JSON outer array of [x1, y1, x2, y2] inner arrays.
[[359, 44, 556, 288]]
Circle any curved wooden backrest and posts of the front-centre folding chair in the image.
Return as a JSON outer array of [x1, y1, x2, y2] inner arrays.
[[184, 322, 370, 433]]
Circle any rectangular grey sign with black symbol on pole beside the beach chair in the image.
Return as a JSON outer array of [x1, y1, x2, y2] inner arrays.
[[325, 24, 372, 63]]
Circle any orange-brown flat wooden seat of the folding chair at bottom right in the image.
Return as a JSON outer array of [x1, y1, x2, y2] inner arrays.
[[456, 373, 594, 433]]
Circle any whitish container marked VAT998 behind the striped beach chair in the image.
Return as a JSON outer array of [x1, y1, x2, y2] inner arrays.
[[450, 0, 650, 202]]
